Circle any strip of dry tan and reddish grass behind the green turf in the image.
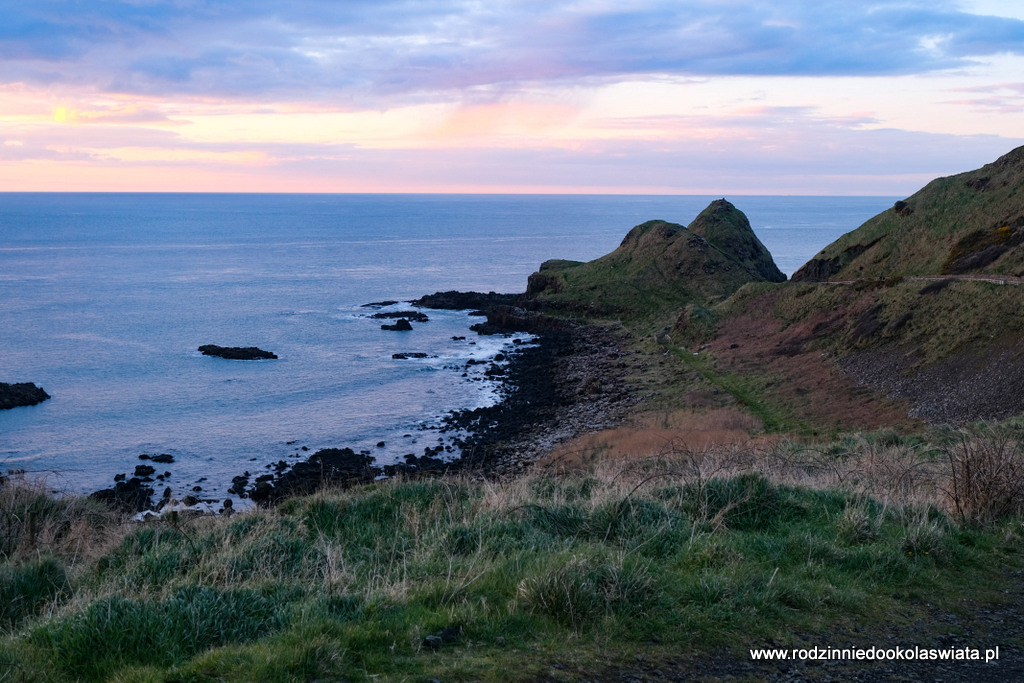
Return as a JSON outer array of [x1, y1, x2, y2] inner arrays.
[[536, 423, 1024, 524]]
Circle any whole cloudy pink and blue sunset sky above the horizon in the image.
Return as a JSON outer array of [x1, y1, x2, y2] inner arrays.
[[0, 0, 1024, 196]]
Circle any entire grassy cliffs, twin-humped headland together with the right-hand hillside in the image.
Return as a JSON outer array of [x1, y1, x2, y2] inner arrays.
[[509, 154, 1024, 433]]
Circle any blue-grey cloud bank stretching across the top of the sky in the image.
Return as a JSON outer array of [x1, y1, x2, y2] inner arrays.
[[6, 0, 1024, 101]]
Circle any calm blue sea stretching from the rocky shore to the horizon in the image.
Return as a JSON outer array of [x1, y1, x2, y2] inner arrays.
[[0, 194, 896, 496]]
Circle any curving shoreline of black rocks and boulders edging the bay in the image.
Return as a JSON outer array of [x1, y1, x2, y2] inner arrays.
[[91, 292, 638, 514]]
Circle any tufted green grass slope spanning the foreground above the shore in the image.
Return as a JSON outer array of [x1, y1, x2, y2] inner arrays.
[[0, 454, 1020, 681]]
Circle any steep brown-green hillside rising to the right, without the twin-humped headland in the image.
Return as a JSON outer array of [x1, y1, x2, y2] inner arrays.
[[674, 147, 1024, 428]]
